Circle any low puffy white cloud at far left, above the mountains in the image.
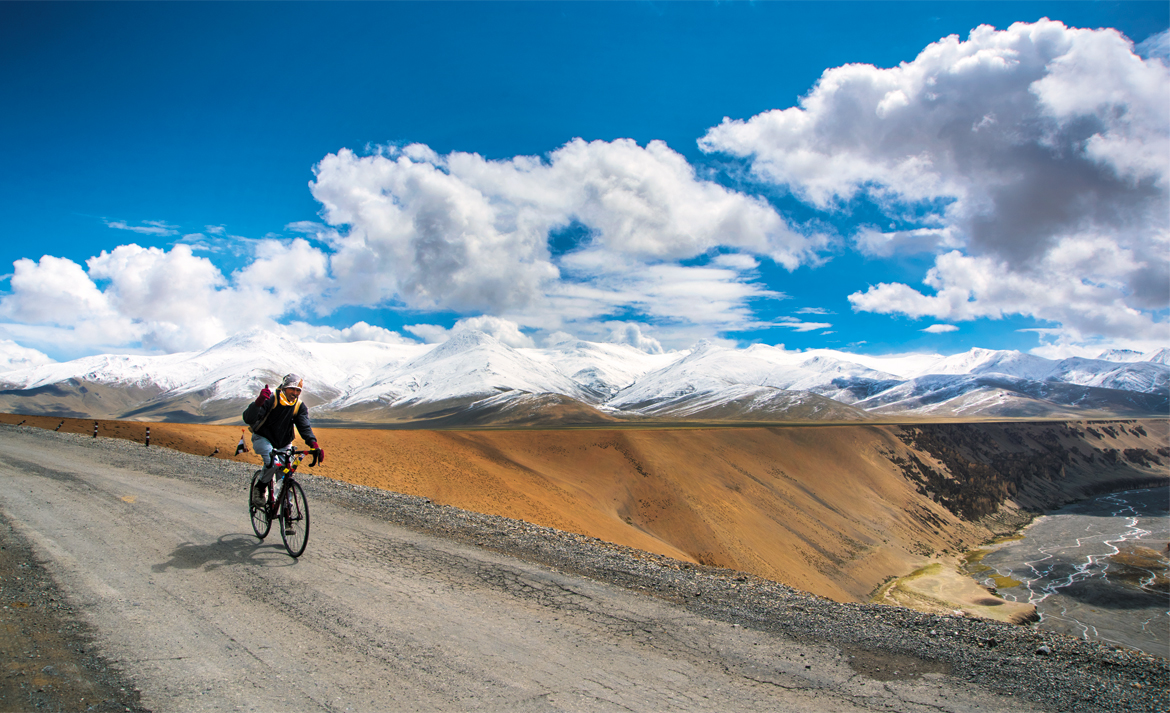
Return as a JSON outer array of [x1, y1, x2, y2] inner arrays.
[[0, 239, 339, 352]]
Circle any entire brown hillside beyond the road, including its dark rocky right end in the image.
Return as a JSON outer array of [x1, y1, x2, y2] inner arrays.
[[0, 414, 1170, 601]]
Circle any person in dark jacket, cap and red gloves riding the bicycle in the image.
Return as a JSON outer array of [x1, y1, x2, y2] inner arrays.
[[243, 373, 325, 507]]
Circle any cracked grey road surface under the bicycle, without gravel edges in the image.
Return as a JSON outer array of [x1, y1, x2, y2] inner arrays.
[[0, 432, 1062, 713]]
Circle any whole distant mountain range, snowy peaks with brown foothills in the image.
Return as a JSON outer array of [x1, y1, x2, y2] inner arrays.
[[0, 330, 1170, 426]]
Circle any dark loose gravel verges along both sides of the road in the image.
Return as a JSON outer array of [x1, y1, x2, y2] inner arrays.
[[0, 419, 1170, 712]]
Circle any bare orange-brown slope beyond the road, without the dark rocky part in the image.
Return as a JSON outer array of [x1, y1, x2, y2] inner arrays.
[[0, 414, 1170, 602]]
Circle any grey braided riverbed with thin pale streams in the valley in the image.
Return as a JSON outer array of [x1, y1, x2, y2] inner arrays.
[[969, 487, 1170, 658]]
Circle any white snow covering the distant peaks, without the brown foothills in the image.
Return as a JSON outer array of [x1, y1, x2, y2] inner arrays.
[[0, 329, 1170, 421]]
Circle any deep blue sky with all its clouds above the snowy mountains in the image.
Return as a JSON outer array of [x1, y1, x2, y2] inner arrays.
[[0, 2, 1170, 358]]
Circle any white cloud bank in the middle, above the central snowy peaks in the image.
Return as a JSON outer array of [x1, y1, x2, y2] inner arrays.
[[311, 139, 824, 338]]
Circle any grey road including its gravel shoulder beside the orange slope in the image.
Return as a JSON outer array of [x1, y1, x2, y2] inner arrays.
[[0, 426, 1170, 712]]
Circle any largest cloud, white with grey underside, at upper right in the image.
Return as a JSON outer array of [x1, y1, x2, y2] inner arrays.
[[700, 20, 1170, 338]]
